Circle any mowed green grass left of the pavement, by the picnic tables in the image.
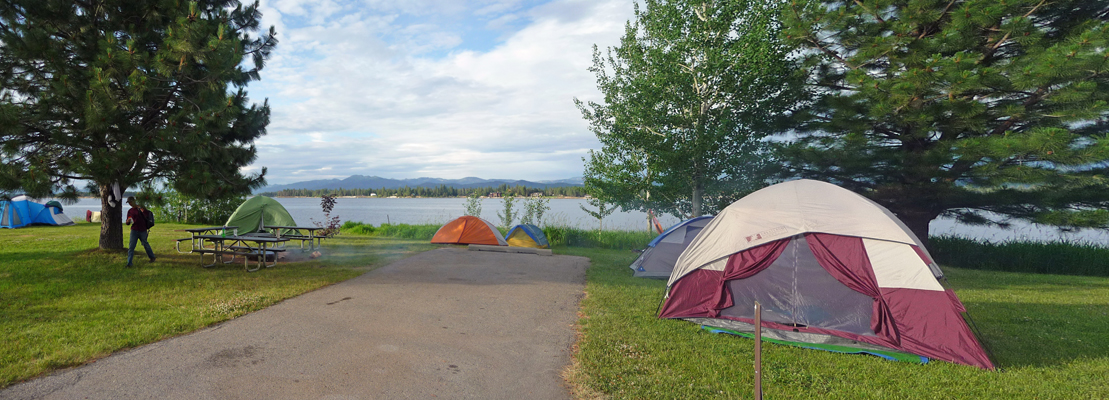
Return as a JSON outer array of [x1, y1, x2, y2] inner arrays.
[[0, 224, 436, 388]]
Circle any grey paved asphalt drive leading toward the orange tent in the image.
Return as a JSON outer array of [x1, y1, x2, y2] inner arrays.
[[0, 248, 589, 400]]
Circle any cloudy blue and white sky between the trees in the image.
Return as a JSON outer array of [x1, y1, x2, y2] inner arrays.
[[245, 0, 632, 184]]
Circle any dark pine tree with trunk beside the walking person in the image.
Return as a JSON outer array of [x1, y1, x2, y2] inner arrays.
[[0, 0, 276, 248]]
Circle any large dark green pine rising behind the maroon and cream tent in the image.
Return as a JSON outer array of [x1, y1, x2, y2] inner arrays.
[[783, 0, 1109, 240]]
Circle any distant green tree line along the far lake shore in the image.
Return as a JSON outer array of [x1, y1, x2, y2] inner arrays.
[[261, 184, 587, 197]]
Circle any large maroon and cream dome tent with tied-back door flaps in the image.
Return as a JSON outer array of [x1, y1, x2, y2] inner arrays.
[[659, 180, 994, 369]]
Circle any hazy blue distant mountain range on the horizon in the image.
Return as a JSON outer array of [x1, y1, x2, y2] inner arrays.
[[254, 175, 584, 193]]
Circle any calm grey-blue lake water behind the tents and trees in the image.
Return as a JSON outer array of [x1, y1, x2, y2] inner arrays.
[[56, 198, 1109, 244]]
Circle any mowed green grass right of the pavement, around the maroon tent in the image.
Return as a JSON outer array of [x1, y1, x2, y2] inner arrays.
[[556, 247, 1109, 399]]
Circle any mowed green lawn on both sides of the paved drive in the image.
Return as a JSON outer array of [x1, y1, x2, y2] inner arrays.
[[0, 219, 1109, 399]]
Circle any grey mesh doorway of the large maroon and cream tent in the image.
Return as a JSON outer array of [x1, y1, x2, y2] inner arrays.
[[720, 235, 875, 336]]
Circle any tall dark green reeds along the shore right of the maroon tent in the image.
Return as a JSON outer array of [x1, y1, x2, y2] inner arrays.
[[928, 236, 1109, 276]]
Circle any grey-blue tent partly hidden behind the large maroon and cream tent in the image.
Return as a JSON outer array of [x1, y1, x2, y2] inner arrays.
[[631, 215, 712, 279]]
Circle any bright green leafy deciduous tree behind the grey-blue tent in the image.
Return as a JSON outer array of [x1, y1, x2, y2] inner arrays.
[[574, 0, 796, 217]]
